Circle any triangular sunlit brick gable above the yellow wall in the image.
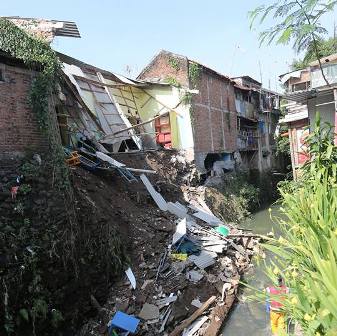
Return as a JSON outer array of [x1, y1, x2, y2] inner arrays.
[[138, 51, 189, 87]]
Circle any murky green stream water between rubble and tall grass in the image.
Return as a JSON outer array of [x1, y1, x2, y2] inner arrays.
[[223, 207, 279, 336]]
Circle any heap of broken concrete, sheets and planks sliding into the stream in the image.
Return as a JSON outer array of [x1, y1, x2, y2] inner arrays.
[[78, 152, 258, 336]]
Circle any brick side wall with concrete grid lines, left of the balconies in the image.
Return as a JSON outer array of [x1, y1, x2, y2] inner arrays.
[[192, 71, 237, 153]]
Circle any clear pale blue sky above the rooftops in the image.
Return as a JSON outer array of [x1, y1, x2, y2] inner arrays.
[[0, 0, 336, 91]]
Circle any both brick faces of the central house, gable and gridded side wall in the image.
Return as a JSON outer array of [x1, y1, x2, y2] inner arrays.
[[138, 51, 237, 158]]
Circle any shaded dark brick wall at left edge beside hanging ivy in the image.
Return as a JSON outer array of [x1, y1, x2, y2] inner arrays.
[[0, 64, 47, 155]]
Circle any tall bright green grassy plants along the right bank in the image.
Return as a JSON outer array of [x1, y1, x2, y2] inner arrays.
[[249, 117, 337, 336]]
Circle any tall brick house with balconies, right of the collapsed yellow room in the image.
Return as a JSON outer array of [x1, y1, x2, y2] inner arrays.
[[138, 51, 280, 173]]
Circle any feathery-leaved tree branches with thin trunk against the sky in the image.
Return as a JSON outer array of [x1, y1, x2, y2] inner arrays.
[[249, 0, 337, 85]]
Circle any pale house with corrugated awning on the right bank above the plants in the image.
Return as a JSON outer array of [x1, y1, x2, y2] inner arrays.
[[279, 54, 337, 179]]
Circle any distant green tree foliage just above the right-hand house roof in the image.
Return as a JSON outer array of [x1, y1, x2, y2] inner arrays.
[[291, 37, 337, 70]]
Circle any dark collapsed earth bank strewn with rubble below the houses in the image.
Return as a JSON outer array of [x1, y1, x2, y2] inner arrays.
[[0, 151, 256, 335]]
